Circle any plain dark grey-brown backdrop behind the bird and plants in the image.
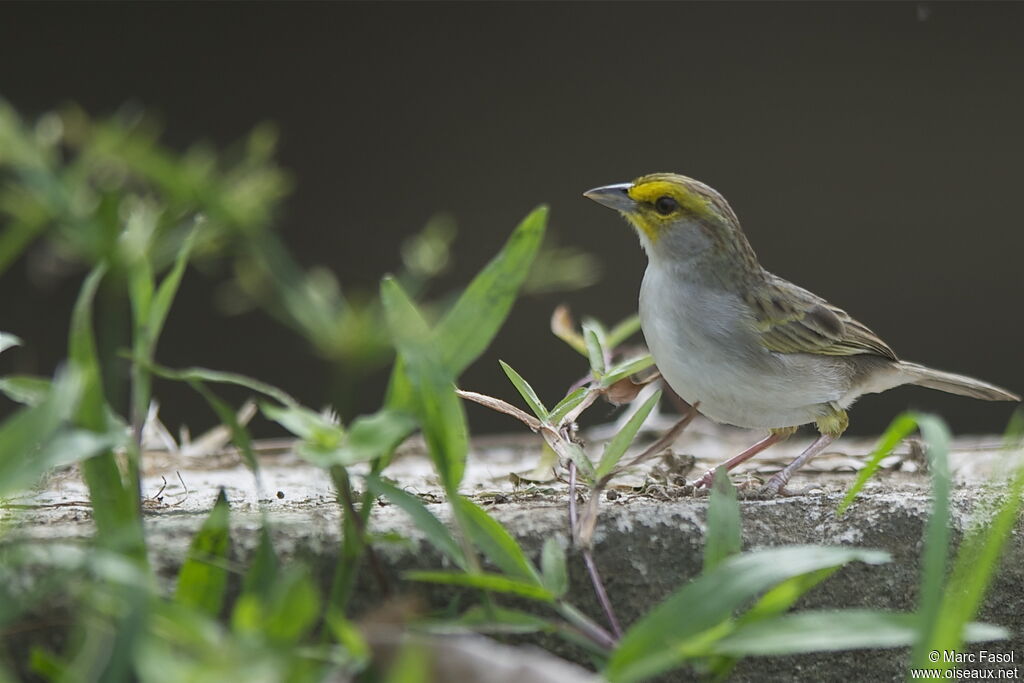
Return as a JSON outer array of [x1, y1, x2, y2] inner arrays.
[[0, 2, 1024, 433]]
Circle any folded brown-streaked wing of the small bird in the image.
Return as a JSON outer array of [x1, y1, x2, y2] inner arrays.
[[746, 275, 897, 360]]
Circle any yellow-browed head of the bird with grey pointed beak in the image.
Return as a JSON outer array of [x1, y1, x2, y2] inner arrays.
[[584, 173, 757, 267]]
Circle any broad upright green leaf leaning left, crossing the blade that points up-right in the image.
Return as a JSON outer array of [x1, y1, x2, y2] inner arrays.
[[381, 278, 469, 496]]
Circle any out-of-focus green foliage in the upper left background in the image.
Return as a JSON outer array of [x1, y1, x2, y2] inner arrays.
[[0, 99, 600, 415]]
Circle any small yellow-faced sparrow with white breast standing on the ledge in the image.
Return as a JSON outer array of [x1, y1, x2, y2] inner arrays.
[[584, 173, 1020, 497]]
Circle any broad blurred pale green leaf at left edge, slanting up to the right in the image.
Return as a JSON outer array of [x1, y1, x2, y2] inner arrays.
[[0, 371, 83, 497]]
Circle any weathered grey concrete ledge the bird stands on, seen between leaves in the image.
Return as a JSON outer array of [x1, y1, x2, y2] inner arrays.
[[2, 422, 1024, 681]]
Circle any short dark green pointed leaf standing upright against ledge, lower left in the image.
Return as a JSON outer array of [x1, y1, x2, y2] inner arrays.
[[174, 488, 229, 616]]
